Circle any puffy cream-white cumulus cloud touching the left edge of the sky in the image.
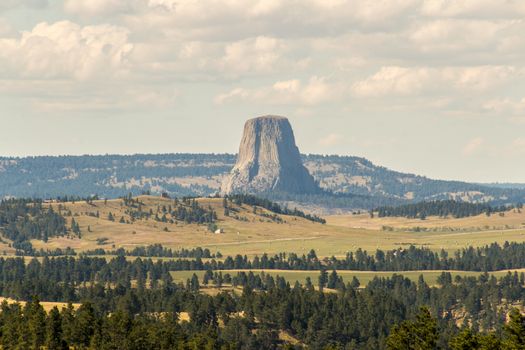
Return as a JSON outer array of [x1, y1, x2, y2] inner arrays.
[[0, 21, 133, 80]]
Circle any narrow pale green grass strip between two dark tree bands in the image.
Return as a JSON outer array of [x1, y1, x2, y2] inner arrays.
[[171, 269, 525, 286]]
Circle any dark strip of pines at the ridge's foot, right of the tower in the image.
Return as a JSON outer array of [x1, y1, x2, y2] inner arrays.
[[374, 200, 523, 220]]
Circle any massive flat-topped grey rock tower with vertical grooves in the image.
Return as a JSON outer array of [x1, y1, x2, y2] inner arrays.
[[221, 116, 319, 194]]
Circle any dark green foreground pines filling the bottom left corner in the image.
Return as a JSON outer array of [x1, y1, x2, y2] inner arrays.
[[0, 296, 286, 350]]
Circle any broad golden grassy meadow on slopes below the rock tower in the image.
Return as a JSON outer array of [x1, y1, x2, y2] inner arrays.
[[6, 196, 525, 256]]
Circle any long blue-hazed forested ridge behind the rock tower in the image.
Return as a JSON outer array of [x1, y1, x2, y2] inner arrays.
[[0, 154, 525, 208]]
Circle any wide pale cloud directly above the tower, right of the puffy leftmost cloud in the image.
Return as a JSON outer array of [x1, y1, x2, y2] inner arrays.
[[126, 36, 298, 81]]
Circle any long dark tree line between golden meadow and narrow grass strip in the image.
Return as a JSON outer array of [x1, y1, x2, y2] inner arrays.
[[145, 242, 525, 271]]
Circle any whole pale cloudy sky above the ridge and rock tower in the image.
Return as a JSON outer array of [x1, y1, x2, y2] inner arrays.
[[0, 0, 525, 182]]
